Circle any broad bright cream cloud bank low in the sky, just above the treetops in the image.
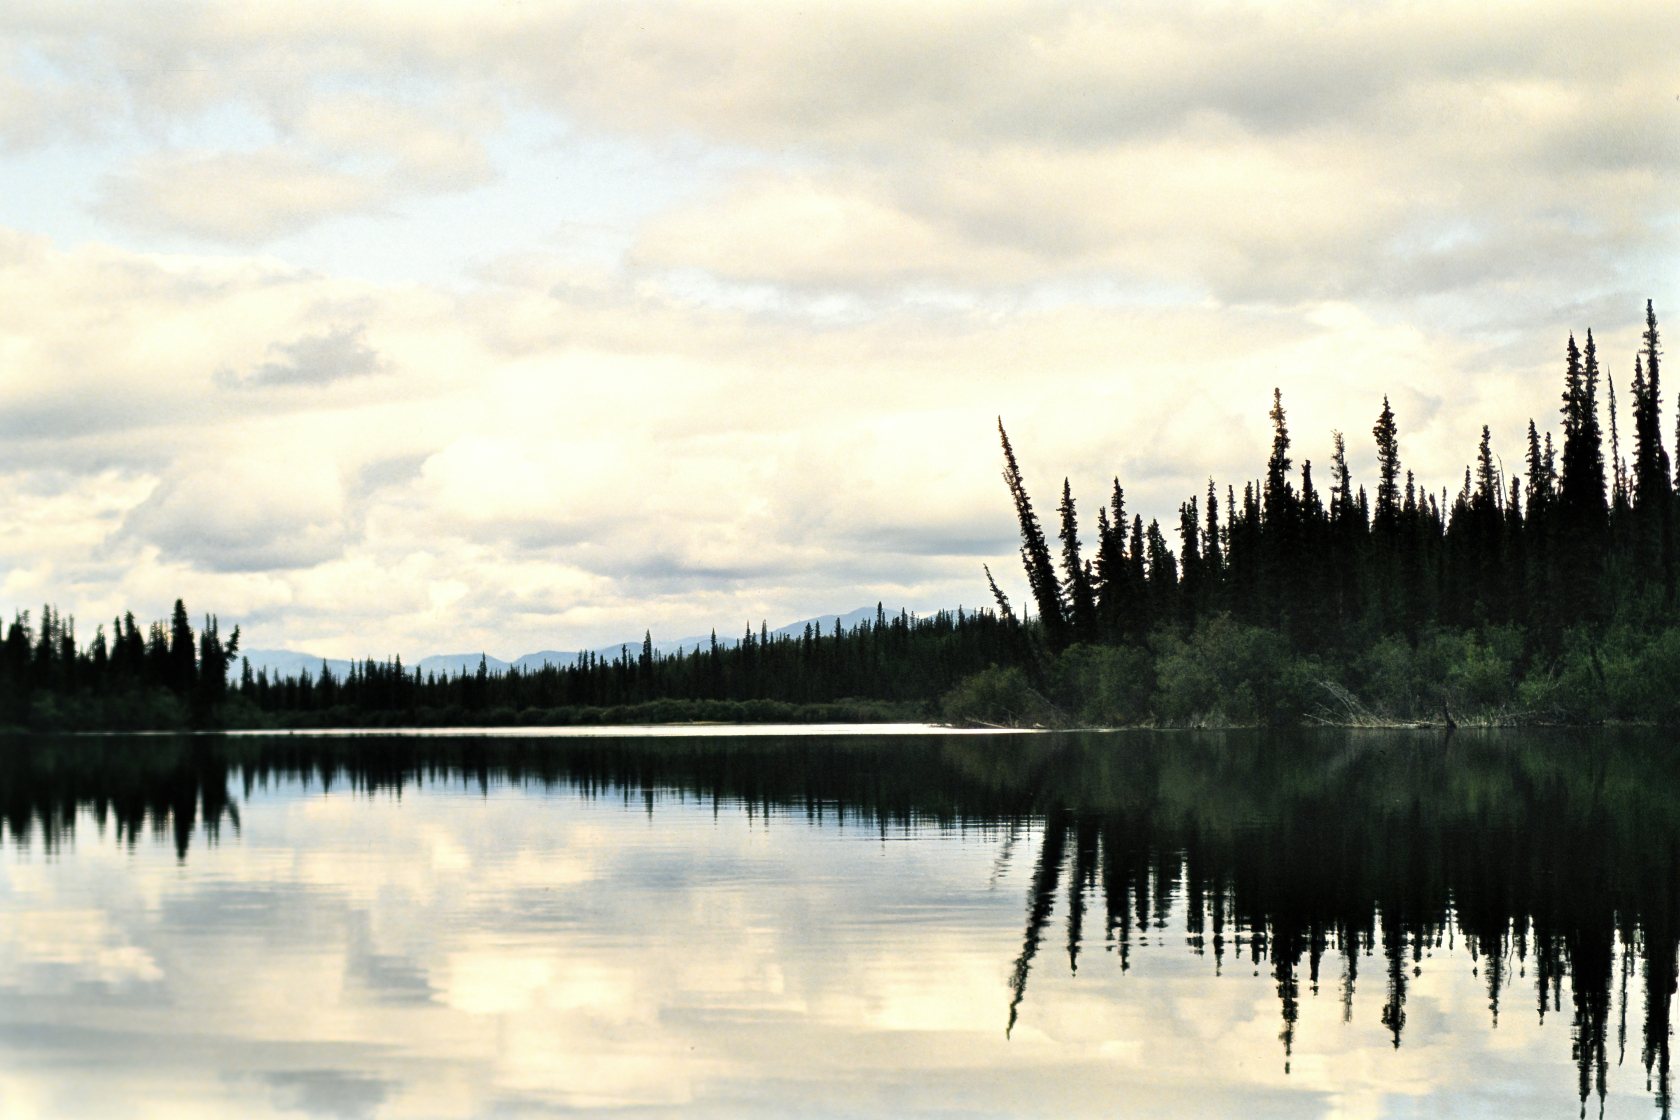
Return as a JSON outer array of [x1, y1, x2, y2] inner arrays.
[[0, 228, 1641, 658]]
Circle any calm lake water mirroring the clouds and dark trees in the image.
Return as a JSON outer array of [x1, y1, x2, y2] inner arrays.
[[0, 729, 1680, 1120]]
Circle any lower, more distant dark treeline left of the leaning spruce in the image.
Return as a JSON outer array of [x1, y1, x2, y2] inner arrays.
[[0, 601, 1015, 729]]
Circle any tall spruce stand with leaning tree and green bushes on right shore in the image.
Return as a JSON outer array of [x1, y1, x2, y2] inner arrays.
[[954, 304, 1680, 722]]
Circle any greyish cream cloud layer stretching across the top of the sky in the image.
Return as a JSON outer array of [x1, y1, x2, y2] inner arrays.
[[0, 3, 1680, 288]]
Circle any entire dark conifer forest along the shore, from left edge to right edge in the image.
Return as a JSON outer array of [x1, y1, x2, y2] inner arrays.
[[0, 304, 1680, 729]]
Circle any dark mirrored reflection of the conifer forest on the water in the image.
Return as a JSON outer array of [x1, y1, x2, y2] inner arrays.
[[0, 729, 1680, 1115]]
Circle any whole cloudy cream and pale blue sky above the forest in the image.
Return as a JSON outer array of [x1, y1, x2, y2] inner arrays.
[[0, 0, 1680, 660]]
